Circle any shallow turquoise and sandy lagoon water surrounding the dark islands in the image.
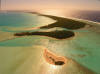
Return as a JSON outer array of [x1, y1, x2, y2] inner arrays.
[[0, 12, 100, 74]]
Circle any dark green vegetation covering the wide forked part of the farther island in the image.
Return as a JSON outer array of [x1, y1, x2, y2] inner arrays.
[[40, 14, 86, 30]]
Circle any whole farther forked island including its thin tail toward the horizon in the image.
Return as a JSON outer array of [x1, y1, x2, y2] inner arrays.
[[28, 12, 91, 30]]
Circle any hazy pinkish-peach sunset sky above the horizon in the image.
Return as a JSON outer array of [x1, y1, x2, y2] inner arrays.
[[2, 0, 100, 10]]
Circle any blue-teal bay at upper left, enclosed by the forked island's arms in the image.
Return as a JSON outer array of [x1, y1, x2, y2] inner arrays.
[[0, 12, 54, 27]]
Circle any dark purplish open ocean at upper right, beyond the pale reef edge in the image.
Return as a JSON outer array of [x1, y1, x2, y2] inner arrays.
[[71, 11, 100, 22]]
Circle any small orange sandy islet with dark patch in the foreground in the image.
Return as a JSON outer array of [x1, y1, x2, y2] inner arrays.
[[44, 49, 67, 65]]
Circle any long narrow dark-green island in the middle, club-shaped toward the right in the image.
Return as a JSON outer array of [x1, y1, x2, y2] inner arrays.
[[14, 30, 75, 39]]
